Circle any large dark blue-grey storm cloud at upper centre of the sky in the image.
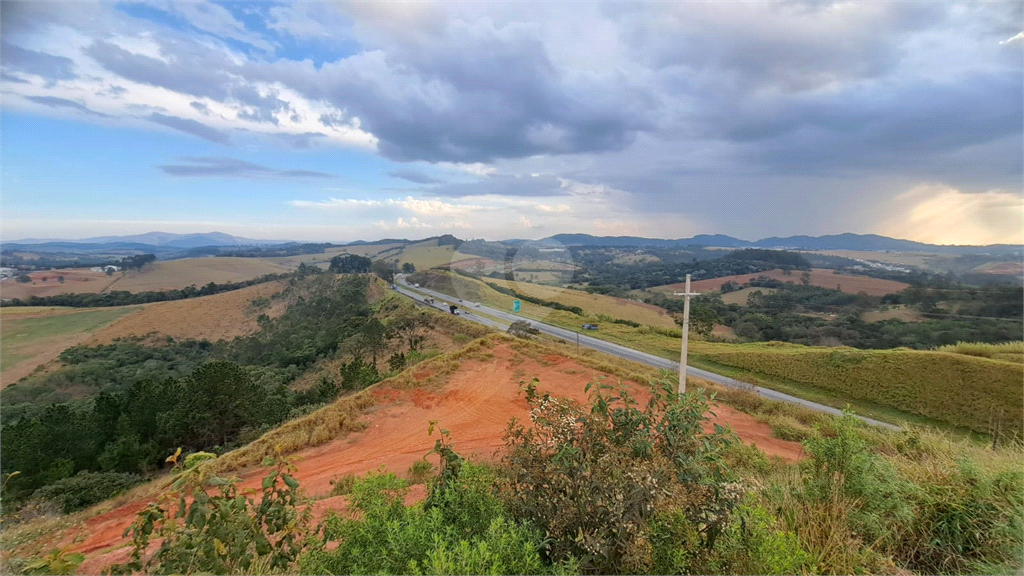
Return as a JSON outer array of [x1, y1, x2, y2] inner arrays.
[[268, 18, 653, 162]]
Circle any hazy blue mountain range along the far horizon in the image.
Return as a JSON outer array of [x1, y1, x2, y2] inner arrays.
[[4, 232, 1024, 254]]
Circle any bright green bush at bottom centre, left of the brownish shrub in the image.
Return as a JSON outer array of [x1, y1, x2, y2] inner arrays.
[[300, 463, 562, 574]]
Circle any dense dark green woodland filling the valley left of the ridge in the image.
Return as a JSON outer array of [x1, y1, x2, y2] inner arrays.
[[0, 275, 444, 506]]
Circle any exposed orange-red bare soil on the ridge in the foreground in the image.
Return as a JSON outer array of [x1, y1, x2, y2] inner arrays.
[[69, 344, 804, 573]]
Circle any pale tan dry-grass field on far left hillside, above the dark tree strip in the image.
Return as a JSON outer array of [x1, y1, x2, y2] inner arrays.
[[109, 257, 291, 292]]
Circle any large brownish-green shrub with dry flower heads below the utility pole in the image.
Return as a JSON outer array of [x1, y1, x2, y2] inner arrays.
[[499, 379, 738, 574]]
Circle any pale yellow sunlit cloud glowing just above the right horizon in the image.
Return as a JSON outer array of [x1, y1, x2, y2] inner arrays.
[[878, 184, 1024, 244]]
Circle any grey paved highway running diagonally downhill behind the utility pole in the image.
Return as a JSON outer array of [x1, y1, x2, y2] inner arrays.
[[395, 276, 900, 430]]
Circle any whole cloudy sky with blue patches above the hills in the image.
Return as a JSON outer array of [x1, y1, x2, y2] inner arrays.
[[0, 0, 1024, 244]]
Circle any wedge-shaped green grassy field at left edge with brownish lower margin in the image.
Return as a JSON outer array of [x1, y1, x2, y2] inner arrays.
[[0, 306, 140, 387]]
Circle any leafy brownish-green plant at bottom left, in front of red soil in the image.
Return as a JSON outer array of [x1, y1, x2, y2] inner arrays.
[[111, 450, 312, 574]]
